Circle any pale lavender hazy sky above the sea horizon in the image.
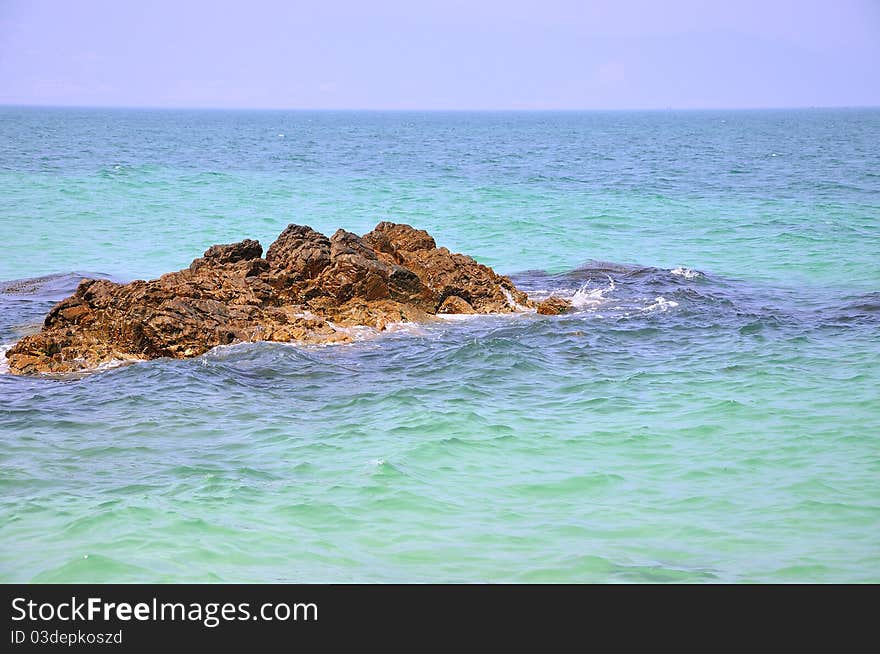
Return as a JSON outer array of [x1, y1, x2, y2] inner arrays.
[[0, 0, 880, 109]]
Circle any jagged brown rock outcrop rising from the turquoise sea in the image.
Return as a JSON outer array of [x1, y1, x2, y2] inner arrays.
[[6, 222, 536, 374]]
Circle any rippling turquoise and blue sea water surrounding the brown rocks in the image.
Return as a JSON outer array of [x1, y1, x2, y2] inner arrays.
[[0, 108, 880, 582]]
